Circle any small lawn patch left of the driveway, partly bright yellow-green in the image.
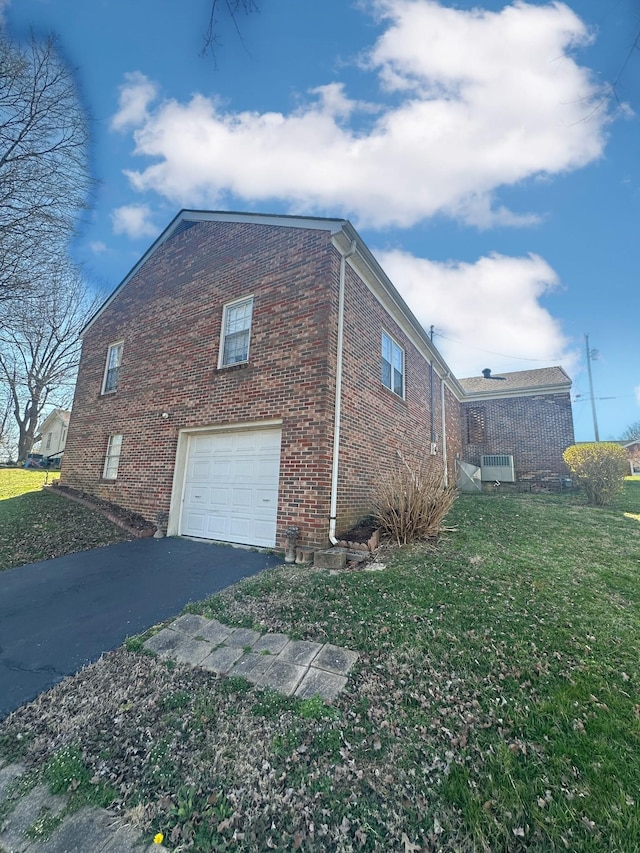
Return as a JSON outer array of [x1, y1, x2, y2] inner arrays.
[[0, 468, 131, 571]]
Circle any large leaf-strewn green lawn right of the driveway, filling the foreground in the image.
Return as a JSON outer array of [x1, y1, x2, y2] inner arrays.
[[0, 480, 640, 853]]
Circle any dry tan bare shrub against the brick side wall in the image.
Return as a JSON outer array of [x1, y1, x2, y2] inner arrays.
[[373, 460, 457, 545]]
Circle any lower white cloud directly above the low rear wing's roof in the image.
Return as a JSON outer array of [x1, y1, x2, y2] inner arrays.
[[376, 251, 575, 377]]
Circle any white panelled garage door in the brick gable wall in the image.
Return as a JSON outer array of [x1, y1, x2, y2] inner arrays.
[[180, 429, 281, 548]]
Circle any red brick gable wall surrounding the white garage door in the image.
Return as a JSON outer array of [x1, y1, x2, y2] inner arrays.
[[62, 222, 338, 541]]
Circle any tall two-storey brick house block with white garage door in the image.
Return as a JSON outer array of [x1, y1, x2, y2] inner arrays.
[[62, 211, 571, 547]]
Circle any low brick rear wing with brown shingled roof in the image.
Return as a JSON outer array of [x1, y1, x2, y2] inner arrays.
[[460, 367, 575, 485]]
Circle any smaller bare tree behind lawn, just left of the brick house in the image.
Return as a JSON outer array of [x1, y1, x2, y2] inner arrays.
[[0, 270, 101, 462]]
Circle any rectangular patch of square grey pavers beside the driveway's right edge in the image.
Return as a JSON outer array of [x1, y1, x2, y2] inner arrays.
[[144, 613, 358, 702]]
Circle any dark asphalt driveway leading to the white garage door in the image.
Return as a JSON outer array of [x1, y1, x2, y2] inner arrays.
[[0, 537, 282, 720]]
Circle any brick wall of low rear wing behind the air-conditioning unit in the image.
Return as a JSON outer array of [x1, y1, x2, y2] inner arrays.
[[462, 393, 574, 481]]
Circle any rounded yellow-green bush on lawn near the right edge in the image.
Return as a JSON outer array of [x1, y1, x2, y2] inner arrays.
[[562, 441, 629, 506]]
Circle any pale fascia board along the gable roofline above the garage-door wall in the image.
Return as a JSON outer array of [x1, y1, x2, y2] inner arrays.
[[79, 210, 345, 338]]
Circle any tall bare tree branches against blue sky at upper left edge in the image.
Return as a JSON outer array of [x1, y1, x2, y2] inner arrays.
[[0, 32, 91, 303]]
